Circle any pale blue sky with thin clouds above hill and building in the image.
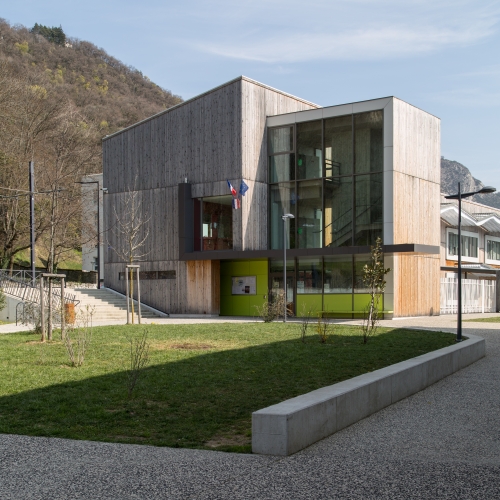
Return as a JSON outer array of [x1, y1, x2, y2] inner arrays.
[[0, 0, 500, 189]]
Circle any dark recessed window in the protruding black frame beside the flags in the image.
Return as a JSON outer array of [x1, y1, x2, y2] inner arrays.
[[202, 195, 233, 250]]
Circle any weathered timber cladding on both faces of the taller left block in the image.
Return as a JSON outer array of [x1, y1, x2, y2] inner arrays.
[[103, 77, 316, 314]]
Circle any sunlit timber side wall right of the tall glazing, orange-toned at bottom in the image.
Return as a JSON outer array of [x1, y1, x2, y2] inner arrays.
[[391, 99, 441, 316]]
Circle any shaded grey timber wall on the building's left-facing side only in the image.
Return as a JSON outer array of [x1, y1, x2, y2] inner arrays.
[[103, 79, 241, 314]]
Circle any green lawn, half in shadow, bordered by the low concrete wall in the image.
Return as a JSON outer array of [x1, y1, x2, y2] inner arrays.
[[0, 323, 455, 452]]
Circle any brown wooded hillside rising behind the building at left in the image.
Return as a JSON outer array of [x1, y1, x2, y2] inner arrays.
[[0, 19, 182, 271]]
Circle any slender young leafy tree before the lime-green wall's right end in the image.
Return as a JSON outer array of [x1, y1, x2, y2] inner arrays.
[[363, 237, 390, 344]]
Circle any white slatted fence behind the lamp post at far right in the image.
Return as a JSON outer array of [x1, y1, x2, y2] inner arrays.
[[441, 278, 496, 314]]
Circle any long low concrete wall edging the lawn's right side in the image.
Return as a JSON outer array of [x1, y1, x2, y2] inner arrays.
[[252, 334, 486, 456]]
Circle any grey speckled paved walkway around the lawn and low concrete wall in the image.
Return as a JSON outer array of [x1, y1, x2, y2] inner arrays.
[[0, 316, 500, 500]]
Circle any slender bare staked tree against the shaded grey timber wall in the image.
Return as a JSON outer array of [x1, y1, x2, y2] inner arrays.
[[109, 183, 151, 323]]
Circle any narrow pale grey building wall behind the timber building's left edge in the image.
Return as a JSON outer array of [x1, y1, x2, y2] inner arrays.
[[81, 174, 104, 283]]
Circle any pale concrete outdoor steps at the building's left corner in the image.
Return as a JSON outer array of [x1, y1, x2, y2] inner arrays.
[[70, 288, 161, 323]]
